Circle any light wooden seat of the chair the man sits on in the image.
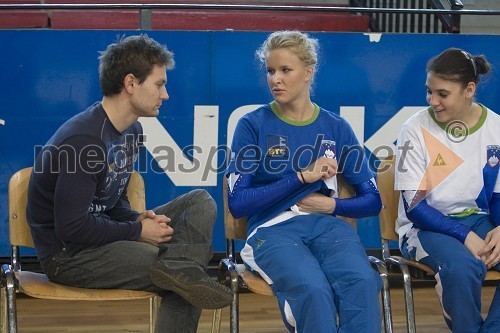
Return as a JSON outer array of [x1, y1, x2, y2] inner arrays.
[[16, 271, 156, 301]]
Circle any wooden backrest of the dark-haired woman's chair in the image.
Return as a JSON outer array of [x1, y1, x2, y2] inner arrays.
[[377, 155, 399, 240]]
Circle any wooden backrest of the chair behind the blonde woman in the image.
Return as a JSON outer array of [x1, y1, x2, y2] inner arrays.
[[222, 174, 356, 240]]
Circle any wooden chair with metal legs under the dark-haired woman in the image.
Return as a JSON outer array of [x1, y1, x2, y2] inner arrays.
[[377, 156, 500, 333]]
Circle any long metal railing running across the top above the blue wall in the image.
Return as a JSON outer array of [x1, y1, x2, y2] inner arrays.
[[0, 0, 500, 33]]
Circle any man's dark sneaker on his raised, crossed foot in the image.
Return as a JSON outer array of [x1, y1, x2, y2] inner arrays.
[[150, 259, 233, 309]]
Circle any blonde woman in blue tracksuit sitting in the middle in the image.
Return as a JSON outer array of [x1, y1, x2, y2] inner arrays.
[[228, 31, 381, 333]]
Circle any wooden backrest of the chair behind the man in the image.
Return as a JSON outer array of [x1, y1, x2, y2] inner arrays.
[[9, 168, 146, 247]]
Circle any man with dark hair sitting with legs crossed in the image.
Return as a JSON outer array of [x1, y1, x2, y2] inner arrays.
[[27, 35, 232, 333]]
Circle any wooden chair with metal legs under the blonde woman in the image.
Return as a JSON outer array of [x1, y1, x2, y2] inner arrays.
[[212, 175, 392, 333]]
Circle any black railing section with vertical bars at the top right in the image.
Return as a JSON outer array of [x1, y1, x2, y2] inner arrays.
[[350, 0, 464, 33]]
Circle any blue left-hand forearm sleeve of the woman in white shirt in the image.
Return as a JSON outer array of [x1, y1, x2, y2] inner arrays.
[[401, 191, 470, 243]]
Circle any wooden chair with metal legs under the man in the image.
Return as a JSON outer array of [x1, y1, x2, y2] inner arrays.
[[0, 168, 157, 333]]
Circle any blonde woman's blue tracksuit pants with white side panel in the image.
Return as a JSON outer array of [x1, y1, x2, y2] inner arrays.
[[241, 214, 381, 333]]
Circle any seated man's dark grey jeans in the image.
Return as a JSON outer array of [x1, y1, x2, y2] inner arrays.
[[41, 190, 217, 333]]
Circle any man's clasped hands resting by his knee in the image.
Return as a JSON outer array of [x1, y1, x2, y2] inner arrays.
[[137, 210, 174, 246]]
